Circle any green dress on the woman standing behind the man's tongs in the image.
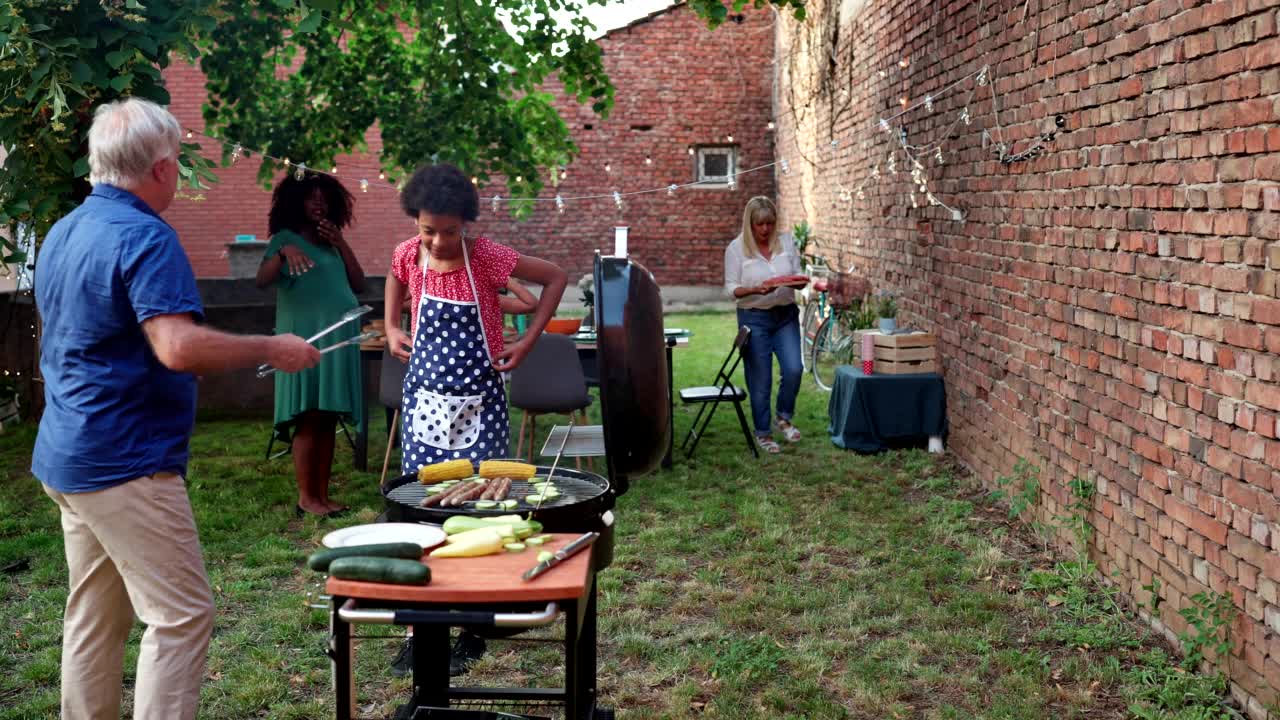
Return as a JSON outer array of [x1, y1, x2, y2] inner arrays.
[[262, 231, 365, 441]]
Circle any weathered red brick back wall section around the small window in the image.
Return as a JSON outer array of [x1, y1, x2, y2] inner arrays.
[[477, 5, 774, 286]]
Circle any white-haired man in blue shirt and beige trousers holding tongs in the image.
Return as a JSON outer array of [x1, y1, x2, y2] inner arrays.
[[31, 99, 320, 720]]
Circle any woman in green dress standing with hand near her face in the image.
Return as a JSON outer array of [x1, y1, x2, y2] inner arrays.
[[257, 173, 365, 518]]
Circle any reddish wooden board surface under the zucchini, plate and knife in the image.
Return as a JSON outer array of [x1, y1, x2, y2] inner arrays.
[[325, 533, 600, 605]]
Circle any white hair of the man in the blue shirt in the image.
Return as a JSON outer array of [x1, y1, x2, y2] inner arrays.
[[88, 97, 182, 190]]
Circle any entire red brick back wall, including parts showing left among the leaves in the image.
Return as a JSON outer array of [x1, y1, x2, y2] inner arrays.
[[165, 6, 774, 286]]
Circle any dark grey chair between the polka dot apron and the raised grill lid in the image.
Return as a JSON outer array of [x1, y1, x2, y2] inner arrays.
[[508, 333, 591, 469]]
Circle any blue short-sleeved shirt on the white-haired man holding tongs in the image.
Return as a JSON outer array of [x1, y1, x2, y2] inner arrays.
[[31, 184, 204, 493]]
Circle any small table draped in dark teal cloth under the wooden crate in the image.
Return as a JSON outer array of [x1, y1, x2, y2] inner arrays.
[[827, 365, 947, 452]]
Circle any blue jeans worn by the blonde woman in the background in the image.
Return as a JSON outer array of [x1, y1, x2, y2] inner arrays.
[[737, 305, 804, 436]]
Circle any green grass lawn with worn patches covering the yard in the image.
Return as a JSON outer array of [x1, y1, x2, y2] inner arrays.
[[0, 314, 1229, 720]]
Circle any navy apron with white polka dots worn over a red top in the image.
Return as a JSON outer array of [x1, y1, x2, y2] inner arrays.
[[401, 241, 509, 473]]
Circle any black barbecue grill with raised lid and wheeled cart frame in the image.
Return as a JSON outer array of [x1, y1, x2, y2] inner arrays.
[[333, 254, 671, 720]]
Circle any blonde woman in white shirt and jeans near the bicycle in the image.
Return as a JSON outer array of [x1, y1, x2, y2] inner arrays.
[[724, 196, 805, 452]]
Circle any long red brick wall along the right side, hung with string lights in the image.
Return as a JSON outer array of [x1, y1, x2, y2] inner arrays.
[[778, 0, 1280, 717]]
